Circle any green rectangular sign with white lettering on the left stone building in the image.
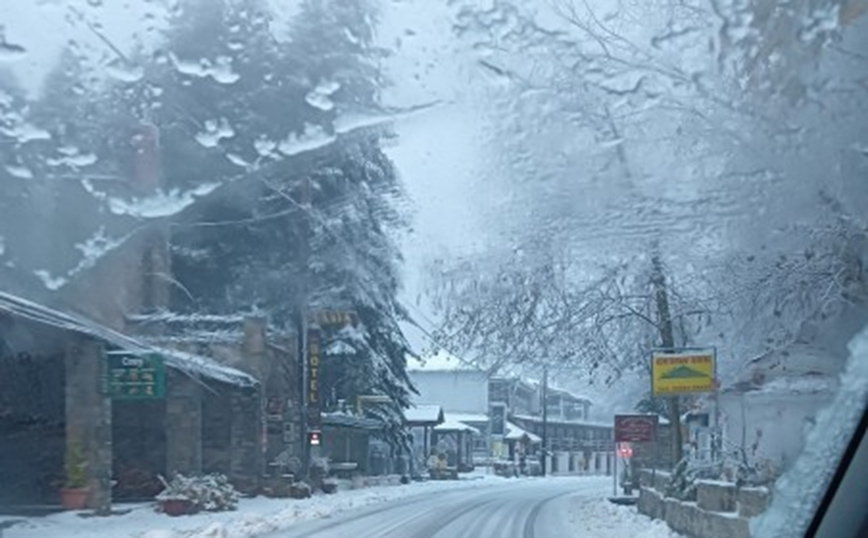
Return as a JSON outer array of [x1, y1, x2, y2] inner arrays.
[[104, 351, 166, 400]]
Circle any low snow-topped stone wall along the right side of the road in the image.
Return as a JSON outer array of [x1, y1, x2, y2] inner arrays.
[[638, 469, 769, 538]]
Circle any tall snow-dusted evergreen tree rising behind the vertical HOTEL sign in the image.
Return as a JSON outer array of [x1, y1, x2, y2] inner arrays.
[[163, 1, 418, 442]]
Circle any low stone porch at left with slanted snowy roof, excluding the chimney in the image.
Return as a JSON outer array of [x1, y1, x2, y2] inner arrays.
[[0, 292, 261, 510]]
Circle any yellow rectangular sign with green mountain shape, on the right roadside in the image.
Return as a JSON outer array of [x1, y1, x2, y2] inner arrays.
[[651, 350, 714, 396]]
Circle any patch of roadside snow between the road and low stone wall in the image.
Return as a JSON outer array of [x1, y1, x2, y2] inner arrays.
[[569, 496, 683, 538]]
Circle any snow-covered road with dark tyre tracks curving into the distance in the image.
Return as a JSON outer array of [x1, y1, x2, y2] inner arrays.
[[267, 477, 677, 538]]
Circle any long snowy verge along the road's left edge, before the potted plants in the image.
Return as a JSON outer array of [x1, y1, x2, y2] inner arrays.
[[3, 474, 526, 538]]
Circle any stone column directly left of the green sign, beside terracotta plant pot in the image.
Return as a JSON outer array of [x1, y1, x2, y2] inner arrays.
[[64, 335, 112, 513]]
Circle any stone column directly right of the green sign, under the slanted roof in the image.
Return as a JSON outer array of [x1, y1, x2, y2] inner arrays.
[[166, 369, 202, 476]]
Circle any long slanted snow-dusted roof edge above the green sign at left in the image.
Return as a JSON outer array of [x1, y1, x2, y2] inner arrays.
[[0, 291, 258, 386]]
